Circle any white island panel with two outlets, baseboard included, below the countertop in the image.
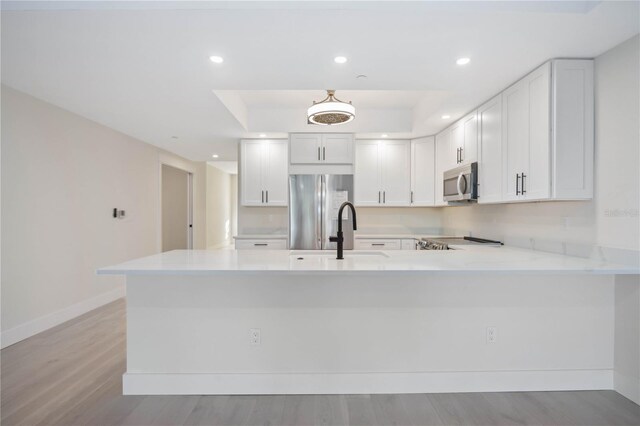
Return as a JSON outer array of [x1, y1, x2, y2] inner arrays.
[[124, 274, 614, 394]]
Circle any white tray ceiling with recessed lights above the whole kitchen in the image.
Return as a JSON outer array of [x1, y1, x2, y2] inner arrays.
[[1, 1, 640, 161]]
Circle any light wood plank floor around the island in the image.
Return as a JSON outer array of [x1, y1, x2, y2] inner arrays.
[[1, 300, 640, 426]]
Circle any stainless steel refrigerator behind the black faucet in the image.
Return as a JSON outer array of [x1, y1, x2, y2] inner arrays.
[[289, 175, 353, 250]]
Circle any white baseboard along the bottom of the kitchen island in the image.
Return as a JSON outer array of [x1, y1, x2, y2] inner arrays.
[[123, 370, 613, 395]]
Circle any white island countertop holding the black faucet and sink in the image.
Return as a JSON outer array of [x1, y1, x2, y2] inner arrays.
[[98, 246, 640, 275]]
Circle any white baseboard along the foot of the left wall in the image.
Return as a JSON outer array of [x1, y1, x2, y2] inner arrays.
[[0, 286, 126, 349]]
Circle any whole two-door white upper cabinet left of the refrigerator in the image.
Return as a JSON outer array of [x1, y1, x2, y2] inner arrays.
[[240, 140, 288, 206]]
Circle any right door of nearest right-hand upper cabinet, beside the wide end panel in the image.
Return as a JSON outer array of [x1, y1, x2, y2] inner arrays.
[[523, 63, 551, 200]]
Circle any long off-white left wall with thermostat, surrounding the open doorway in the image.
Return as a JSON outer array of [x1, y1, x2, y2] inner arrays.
[[1, 86, 205, 346]]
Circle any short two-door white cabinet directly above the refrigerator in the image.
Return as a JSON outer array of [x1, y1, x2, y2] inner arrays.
[[289, 133, 353, 164]]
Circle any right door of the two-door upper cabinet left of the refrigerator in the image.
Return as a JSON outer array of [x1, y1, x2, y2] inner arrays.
[[263, 141, 288, 206]]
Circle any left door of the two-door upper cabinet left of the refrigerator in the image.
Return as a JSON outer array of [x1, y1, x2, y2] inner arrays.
[[240, 140, 266, 206]]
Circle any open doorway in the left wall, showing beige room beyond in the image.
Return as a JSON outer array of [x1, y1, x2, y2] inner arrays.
[[161, 164, 193, 252]]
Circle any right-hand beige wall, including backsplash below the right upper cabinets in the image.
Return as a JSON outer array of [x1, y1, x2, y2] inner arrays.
[[443, 36, 640, 260]]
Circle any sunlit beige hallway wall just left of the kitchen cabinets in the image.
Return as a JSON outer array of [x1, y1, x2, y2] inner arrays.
[[207, 165, 237, 249]]
